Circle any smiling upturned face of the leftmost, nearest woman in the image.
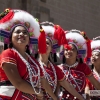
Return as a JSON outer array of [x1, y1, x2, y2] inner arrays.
[[12, 26, 29, 46]]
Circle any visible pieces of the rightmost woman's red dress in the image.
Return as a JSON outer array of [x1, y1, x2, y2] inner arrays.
[[86, 70, 100, 100]]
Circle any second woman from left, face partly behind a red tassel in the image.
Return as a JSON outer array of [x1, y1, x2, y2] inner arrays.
[[35, 22, 83, 100]]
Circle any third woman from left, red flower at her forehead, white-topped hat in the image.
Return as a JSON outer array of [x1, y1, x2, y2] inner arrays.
[[59, 30, 100, 100]]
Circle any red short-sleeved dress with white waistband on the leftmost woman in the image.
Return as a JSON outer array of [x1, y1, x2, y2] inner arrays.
[[0, 49, 43, 100]]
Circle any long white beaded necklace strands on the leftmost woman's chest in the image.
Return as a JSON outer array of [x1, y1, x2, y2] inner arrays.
[[12, 48, 41, 94]]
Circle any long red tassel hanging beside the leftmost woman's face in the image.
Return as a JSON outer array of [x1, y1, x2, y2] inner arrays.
[[38, 26, 46, 54]]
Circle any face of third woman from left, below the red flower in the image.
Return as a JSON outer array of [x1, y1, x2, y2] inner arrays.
[[64, 44, 77, 60]]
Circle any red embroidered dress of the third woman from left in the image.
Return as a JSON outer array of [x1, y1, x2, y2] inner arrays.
[[60, 63, 92, 100]]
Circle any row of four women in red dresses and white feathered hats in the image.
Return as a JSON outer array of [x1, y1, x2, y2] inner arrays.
[[0, 9, 100, 100]]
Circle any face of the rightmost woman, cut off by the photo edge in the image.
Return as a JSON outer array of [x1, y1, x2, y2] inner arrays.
[[91, 51, 100, 66]]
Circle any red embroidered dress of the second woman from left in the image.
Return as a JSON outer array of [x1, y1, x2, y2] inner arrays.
[[40, 62, 65, 100]]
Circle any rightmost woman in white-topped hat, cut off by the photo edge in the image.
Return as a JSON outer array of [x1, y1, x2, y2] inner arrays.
[[85, 36, 100, 100]]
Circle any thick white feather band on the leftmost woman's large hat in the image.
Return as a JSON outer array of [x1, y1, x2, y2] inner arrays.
[[0, 9, 40, 37]]
